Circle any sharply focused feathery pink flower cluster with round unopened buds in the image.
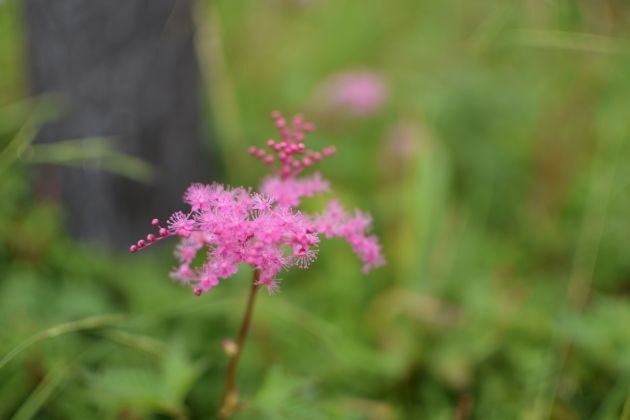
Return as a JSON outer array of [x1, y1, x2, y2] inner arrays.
[[130, 112, 385, 295]]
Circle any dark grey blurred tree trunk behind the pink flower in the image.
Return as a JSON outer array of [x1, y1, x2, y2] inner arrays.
[[25, 0, 213, 248]]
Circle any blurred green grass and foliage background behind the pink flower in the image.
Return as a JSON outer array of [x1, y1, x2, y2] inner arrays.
[[0, 0, 630, 420]]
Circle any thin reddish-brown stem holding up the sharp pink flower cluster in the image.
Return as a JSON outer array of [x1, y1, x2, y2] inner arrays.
[[218, 270, 260, 420]]
